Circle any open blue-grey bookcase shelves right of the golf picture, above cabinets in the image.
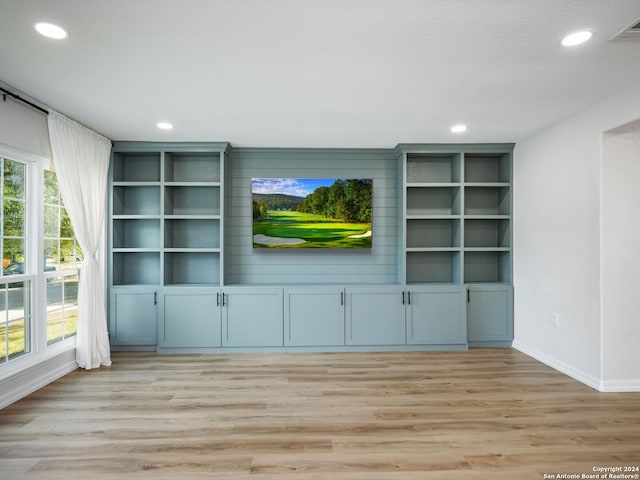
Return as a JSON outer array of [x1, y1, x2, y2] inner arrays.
[[399, 145, 512, 284]]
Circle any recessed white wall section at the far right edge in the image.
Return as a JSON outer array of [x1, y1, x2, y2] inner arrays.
[[601, 121, 640, 390]]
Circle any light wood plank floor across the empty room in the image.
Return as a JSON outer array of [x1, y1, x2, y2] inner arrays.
[[0, 349, 640, 480]]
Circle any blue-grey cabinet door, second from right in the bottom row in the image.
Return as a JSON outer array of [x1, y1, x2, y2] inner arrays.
[[406, 285, 467, 345]]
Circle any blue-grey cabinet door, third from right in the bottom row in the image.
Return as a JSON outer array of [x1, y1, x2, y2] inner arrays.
[[346, 286, 406, 345]]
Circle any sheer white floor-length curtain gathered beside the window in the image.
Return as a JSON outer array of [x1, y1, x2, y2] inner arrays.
[[48, 111, 111, 370]]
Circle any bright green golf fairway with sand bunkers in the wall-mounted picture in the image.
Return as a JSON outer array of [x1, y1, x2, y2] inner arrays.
[[253, 210, 371, 248]]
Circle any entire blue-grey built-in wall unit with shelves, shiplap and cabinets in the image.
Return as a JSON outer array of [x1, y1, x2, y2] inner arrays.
[[108, 142, 513, 351]]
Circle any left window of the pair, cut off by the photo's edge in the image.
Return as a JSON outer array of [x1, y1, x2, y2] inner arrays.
[[0, 157, 31, 363]]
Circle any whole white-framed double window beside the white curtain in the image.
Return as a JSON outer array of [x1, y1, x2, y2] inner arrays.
[[0, 152, 83, 364]]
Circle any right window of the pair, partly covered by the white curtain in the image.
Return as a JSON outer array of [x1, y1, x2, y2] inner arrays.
[[44, 170, 82, 345]]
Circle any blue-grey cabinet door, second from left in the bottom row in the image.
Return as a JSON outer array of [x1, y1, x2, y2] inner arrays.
[[158, 288, 221, 348]]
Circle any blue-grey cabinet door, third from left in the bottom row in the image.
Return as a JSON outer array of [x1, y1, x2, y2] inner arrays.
[[222, 287, 283, 347]]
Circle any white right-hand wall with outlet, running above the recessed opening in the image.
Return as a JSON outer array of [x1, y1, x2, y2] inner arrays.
[[514, 84, 640, 389]]
